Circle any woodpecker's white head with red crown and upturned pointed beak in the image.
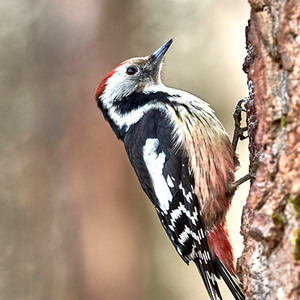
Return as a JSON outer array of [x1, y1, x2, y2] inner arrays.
[[96, 39, 173, 109]]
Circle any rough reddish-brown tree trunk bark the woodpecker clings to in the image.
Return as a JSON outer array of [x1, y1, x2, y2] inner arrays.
[[238, 0, 300, 300]]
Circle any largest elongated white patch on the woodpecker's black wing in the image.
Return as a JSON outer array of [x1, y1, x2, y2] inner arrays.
[[143, 138, 172, 210]]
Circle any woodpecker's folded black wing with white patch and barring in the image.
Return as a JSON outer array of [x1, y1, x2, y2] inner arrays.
[[124, 110, 222, 299]]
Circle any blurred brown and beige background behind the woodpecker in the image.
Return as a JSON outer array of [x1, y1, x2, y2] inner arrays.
[[0, 0, 249, 300]]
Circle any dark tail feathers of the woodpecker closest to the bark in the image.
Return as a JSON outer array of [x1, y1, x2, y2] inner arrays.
[[215, 255, 246, 300]]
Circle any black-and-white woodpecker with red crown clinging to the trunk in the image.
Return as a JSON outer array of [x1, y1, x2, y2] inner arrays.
[[95, 39, 245, 300]]
